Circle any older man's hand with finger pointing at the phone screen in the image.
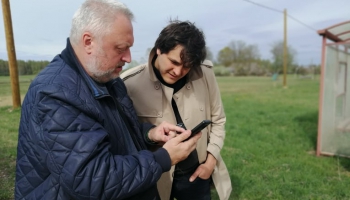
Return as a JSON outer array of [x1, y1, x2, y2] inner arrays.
[[148, 122, 185, 145]]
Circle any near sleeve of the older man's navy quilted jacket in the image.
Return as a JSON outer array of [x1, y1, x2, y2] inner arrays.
[[29, 85, 170, 199]]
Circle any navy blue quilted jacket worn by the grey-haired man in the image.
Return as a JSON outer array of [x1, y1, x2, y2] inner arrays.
[[15, 39, 171, 200]]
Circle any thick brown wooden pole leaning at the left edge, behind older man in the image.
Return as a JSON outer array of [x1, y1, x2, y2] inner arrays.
[[1, 0, 21, 108]]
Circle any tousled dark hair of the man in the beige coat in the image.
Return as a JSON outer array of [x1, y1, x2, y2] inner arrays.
[[154, 20, 207, 68]]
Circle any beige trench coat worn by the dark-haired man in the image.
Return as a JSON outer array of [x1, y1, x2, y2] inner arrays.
[[120, 50, 232, 200]]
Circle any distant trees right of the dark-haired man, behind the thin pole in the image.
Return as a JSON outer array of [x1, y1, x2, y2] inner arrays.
[[211, 40, 320, 76]]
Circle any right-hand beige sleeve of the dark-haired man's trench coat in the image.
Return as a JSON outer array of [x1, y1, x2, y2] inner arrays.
[[203, 67, 226, 159]]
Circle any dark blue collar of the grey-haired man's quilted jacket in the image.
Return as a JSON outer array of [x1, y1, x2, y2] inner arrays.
[[61, 38, 110, 99]]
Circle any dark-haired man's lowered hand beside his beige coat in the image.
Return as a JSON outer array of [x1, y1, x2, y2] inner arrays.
[[190, 152, 216, 182]]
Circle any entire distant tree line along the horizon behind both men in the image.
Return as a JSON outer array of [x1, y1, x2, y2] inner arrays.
[[0, 40, 320, 76]]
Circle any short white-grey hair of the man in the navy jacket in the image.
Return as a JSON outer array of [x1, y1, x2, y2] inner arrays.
[[69, 0, 134, 45]]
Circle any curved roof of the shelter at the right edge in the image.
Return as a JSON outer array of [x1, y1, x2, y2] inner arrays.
[[317, 20, 350, 42]]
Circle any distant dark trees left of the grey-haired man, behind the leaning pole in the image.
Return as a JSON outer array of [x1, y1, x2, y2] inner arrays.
[[0, 59, 49, 76]]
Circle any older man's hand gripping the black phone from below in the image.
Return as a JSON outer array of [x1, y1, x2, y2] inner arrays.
[[163, 130, 202, 165]]
